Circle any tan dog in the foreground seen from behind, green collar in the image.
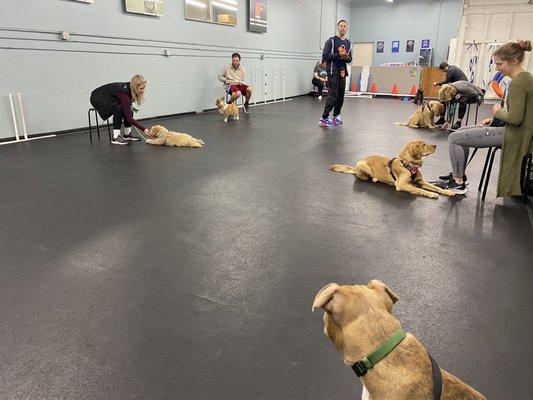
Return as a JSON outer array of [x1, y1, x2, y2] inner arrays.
[[313, 280, 486, 400]]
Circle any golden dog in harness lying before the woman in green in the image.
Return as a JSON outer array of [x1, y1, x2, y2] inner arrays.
[[329, 140, 455, 199]]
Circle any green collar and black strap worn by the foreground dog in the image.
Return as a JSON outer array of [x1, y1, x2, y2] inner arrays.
[[352, 328, 442, 400]]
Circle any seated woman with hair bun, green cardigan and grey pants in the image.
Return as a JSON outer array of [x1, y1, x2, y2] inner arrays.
[[441, 40, 533, 197]]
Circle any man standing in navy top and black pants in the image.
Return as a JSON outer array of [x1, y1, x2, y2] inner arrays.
[[318, 19, 352, 127]]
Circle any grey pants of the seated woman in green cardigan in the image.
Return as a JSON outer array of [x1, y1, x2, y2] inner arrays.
[[448, 125, 505, 178]]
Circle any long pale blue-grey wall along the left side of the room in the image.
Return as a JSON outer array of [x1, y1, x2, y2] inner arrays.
[[0, 0, 350, 139]]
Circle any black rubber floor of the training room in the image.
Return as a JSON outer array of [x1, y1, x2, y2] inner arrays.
[[0, 97, 533, 400]]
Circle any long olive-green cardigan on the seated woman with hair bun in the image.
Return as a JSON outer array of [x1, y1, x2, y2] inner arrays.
[[494, 71, 533, 197]]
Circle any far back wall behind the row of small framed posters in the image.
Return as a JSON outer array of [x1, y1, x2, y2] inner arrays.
[[351, 0, 462, 65]]
